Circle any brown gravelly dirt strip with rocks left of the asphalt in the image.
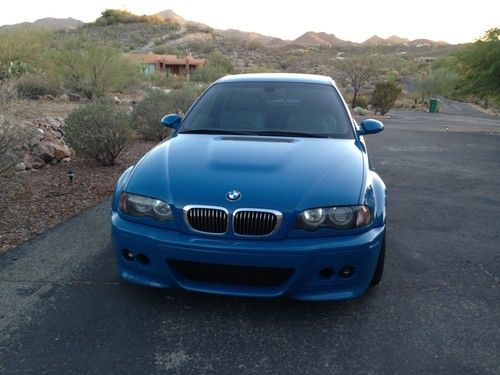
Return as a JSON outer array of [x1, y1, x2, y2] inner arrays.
[[0, 141, 155, 252]]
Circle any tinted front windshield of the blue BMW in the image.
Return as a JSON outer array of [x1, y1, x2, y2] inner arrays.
[[179, 82, 354, 139]]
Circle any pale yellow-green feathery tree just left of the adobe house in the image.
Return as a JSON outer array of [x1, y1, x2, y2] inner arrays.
[[51, 34, 139, 99]]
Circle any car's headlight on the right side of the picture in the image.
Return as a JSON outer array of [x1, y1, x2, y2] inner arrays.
[[295, 206, 373, 231]]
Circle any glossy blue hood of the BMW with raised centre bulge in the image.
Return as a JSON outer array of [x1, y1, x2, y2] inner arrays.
[[126, 134, 365, 212]]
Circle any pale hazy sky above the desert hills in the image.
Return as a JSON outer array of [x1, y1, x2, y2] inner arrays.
[[0, 0, 500, 43]]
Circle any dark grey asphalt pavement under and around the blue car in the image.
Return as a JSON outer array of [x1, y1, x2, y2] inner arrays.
[[0, 111, 500, 374]]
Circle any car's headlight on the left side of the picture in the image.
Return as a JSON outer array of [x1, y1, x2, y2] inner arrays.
[[120, 193, 174, 221]]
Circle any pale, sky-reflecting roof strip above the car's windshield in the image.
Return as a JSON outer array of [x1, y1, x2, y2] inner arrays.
[[216, 73, 335, 85]]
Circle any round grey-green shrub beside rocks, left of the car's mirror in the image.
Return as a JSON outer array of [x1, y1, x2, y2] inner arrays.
[[64, 101, 133, 165]]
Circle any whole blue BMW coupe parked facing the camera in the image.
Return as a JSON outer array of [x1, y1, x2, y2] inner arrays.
[[111, 74, 386, 300]]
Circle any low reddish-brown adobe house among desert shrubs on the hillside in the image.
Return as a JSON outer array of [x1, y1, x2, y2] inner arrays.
[[131, 52, 208, 76]]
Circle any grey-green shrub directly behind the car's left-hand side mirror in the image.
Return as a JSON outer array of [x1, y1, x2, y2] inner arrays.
[[132, 85, 203, 141]]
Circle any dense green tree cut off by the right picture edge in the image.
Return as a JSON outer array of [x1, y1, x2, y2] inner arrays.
[[456, 28, 500, 104]]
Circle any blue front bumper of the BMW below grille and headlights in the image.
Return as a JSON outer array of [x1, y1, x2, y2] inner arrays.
[[112, 212, 385, 300]]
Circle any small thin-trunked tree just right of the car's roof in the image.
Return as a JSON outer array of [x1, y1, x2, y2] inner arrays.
[[337, 55, 381, 108]]
